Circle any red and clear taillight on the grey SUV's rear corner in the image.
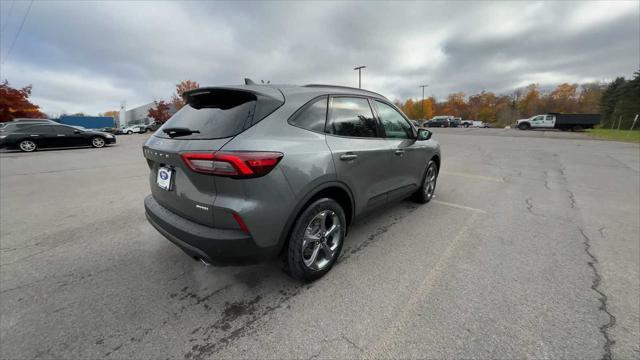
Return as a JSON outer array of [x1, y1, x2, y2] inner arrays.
[[182, 151, 283, 178]]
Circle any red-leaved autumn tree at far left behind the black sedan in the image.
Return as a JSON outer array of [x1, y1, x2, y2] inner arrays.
[[0, 80, 46, 122]]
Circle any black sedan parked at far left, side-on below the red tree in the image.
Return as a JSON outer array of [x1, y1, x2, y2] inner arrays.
[[0, 124, 116, 152]]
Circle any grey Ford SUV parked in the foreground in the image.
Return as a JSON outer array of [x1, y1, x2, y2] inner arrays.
[[143, 85, 441, 281]]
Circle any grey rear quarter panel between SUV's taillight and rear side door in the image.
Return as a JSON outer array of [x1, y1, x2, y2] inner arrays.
[[219, 98, 336, 246]]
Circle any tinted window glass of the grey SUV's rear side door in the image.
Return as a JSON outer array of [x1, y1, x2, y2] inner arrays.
[[327, 97, 377, 137]]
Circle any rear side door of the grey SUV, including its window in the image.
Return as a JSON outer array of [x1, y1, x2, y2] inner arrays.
[[326, 96, 394, 213]]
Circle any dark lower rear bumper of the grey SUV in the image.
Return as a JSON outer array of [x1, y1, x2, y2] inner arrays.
[[144, 195, 279, 265]]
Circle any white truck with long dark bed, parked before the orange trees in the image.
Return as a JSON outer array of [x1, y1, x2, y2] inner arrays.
[[516, 113, 600, 131]]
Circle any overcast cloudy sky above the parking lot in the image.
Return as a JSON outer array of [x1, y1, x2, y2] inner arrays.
[[0, 0, 640, 114]]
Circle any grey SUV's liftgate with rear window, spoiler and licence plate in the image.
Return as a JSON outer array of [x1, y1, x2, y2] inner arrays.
[[143, 87, 284, 226]]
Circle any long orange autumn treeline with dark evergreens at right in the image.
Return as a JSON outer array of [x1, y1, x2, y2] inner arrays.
[[396, 72, 640, 129]]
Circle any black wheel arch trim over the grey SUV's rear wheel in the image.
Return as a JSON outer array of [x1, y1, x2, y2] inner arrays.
[[279, 181, 355, 254]]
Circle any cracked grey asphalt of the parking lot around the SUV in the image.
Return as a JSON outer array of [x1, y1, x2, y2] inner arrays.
[[0, 129, 640, 359]]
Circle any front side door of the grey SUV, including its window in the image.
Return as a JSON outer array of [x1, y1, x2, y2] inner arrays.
[[373, 100, 427, 200]]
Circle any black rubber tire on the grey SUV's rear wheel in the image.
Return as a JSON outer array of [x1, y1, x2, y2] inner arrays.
[[286, 198, 347, 282]]
